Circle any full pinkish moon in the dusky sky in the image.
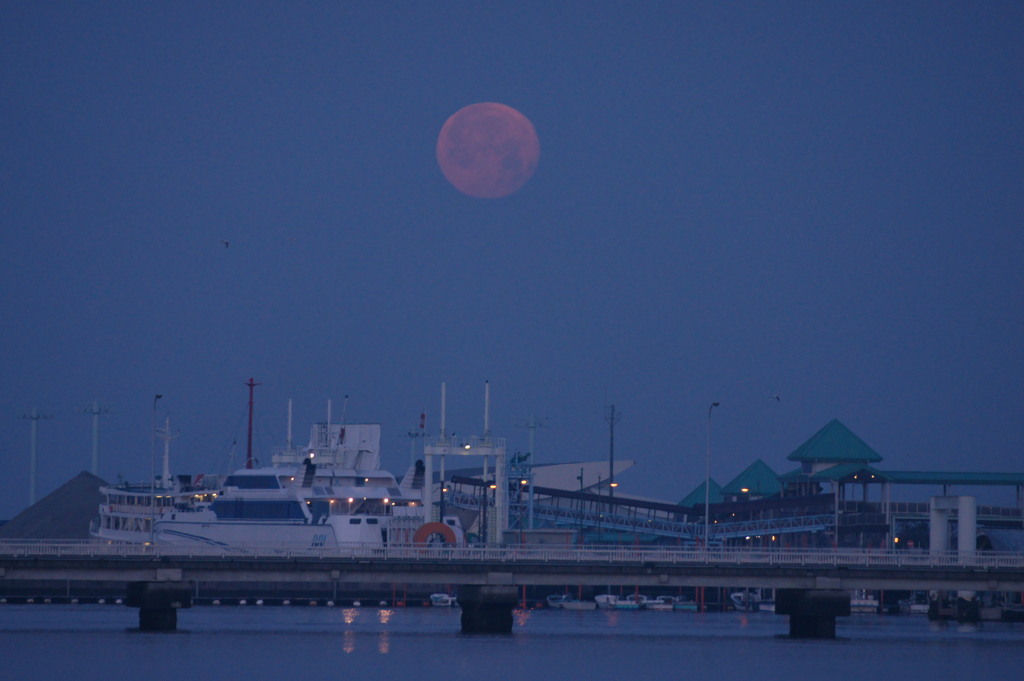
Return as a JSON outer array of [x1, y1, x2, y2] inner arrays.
[[437, 101, 541, 199]]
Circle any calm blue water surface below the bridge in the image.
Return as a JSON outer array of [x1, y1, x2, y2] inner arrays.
[[0, 605, 1024, 681]]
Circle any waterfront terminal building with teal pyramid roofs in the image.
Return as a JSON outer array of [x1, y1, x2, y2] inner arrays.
[[682, 419, 1024, 550]]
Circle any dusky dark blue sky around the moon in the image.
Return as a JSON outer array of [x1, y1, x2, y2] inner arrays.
[[0, 1, 1024, 517]]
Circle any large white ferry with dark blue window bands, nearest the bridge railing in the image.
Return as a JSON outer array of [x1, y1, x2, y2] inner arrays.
[[155, 423, 462, 548]]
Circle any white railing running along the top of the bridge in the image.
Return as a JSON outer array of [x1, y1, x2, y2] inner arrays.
[[6, 540, 1024, 569]]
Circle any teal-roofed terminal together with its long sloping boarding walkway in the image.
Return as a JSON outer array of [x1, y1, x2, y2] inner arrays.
[[448, 420, 1024, 552]]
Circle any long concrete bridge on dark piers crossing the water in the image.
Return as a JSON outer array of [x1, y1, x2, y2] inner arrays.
[[0, 541, 1024, 636]]
